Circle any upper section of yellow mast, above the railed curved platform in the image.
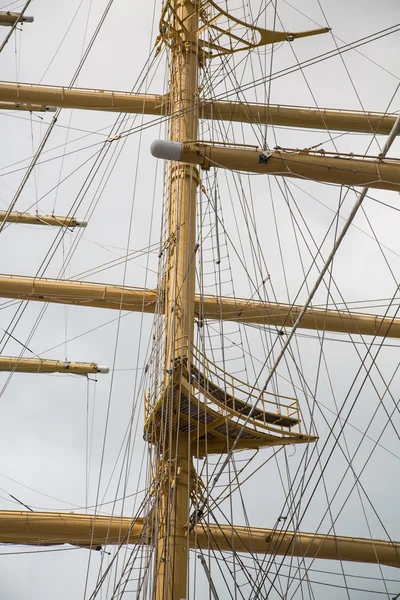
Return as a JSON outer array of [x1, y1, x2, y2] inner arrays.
[[165, 0, 199, 367]]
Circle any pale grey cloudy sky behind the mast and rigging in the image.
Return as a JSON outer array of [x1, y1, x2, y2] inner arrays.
[[0, 0, 400, 600]]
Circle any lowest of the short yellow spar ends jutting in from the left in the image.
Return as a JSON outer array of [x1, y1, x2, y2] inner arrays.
[[0, 356, 109, 375]]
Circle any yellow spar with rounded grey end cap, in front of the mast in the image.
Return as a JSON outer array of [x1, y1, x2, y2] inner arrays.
[[151, 140, 400, 191]]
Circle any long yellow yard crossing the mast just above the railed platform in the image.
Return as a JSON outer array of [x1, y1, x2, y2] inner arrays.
[[0, 275, 400, 338]]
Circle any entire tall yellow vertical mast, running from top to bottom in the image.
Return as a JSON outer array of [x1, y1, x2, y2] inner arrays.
[[155, 0, 199, 600]]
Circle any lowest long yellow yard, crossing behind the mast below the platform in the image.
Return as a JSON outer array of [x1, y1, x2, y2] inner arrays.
[[0, 510, 400, 567]]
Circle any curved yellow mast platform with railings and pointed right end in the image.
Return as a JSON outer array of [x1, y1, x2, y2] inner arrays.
[[144, 346, 317, 457]]
